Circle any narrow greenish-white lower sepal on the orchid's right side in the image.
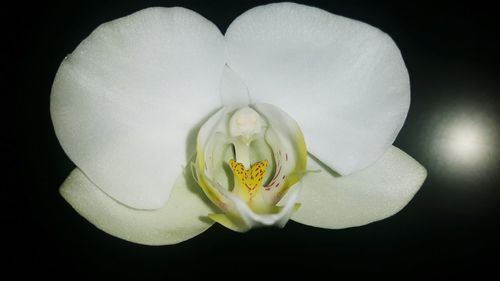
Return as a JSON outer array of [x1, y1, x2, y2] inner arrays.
[[292, 146, 427, 229]]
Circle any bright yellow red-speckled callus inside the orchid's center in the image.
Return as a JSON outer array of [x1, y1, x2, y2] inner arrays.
[[229, 160, 268, 201]]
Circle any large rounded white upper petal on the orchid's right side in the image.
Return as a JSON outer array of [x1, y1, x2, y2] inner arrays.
[[226, 3, 410, 174]]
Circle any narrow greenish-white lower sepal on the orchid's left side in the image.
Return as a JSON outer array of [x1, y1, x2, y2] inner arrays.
[[60, 169, 213, 245]]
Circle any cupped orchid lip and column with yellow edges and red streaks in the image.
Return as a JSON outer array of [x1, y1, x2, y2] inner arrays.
[[193, 104, 307, 231]]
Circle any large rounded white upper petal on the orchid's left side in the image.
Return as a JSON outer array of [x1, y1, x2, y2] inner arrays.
[[51, 8, 224, 209]]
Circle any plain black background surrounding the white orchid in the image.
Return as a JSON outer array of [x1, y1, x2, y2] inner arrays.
[[13, 1, 500, 280]]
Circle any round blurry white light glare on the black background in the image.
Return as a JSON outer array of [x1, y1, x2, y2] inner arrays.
[[428, 107, 498, 185]]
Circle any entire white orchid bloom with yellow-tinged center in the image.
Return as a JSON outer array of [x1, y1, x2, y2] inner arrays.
[[51, 3, 426, 245]]
